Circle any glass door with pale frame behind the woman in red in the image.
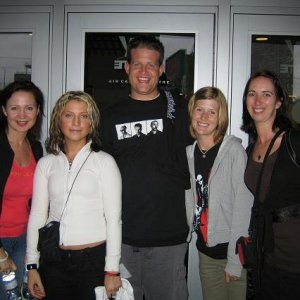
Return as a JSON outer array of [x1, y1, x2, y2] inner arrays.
[[0, 7, 50, 141]]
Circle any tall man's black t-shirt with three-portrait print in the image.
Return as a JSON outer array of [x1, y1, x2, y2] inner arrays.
[[101, 96, 189, 247]]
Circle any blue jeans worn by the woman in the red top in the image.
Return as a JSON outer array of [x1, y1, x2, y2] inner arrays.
[[1, 233, 26, 288]]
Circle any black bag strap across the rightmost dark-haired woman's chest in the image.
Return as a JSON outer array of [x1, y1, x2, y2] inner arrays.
[[248, 129, 283, 236]]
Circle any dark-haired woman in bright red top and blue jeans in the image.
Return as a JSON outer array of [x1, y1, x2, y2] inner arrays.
[[0, 81, 44, 299]]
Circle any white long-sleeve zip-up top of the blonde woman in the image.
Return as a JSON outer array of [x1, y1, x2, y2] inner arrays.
[[26, 143, 122, 271]]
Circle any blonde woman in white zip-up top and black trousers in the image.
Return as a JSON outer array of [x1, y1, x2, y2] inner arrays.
[[26, 92, 121, 300]]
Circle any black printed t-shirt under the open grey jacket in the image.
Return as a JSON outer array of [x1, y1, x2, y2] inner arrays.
[[194, 143, 228, 259]]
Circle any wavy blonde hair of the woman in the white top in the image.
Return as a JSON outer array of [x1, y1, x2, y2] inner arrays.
[[46, 91, 100, 155]]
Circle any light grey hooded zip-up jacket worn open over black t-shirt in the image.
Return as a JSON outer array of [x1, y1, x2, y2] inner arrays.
[[186, 135, 253, 276]]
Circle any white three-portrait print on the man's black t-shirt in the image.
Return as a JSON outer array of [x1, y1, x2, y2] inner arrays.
[[116, 119, 163, 140]]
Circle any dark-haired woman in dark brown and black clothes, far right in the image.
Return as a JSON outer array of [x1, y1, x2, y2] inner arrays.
[[241, 70, 300, 300]]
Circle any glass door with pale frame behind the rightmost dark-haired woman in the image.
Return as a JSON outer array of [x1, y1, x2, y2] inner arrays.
[[231, 14, 300, 146]]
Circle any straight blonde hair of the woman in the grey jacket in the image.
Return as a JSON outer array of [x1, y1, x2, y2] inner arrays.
[[188, 86, 228, 143]]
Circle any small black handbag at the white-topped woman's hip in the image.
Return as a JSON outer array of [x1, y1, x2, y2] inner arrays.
[[37, 221, 61, 263]]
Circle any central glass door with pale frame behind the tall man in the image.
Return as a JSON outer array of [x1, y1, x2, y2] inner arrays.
[[65, 10, 215, 300]]
